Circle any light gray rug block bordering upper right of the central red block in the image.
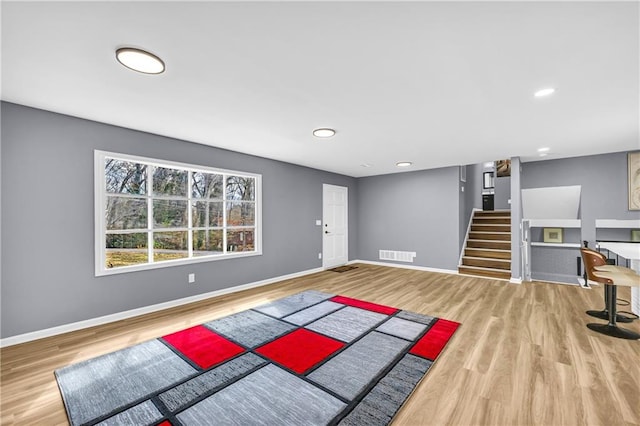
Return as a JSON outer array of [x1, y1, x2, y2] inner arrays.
[[305, 306, 387, 342]]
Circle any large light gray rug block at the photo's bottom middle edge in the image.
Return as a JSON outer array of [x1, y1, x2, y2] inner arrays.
[[177, 364, 346, 426]]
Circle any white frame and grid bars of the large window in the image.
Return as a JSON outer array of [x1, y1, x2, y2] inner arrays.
[[94, 150, 262, 277]]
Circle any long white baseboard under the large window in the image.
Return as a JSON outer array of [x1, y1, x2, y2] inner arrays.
[[0, 268, 324, 348]]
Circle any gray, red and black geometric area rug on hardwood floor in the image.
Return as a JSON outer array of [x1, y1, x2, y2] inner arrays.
[[55, 291, 460, 426]]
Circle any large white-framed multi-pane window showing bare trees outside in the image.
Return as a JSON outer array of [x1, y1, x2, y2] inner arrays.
[[95, 151, 261, 275]]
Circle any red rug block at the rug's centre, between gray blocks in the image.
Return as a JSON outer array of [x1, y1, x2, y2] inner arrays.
[[255, 328, 345, 374]]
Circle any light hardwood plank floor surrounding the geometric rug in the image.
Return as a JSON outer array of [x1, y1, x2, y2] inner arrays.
[[0, 264, 640, 426]]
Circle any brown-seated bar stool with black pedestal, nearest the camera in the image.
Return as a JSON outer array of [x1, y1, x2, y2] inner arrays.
[[587, 265, 640, 340]]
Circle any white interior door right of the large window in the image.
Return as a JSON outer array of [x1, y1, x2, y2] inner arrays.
[[322, 184, 349, 268]]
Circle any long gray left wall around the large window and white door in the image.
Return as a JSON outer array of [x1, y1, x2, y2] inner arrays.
[[1, 103, 358, 337]]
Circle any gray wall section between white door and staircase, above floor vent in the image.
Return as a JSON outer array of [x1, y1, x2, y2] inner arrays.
[[356, 167, 460, 270]]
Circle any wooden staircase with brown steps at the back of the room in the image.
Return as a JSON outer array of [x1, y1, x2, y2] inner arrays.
[[458, 210, 511, 280]]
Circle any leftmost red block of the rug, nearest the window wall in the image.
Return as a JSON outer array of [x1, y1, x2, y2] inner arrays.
[[163, 325, 244, 368]]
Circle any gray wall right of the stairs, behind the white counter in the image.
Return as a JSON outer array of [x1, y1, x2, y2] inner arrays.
[[521, 152, 640, 281]]
